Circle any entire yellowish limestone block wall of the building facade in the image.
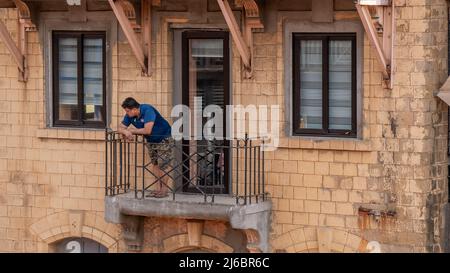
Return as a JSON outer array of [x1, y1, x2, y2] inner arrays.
[[0, 0, 448, 252]]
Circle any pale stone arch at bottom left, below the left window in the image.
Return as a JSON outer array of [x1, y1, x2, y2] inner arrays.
[[30, 211, 120, 252]]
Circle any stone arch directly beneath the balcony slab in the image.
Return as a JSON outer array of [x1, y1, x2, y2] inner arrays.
[[163, 234, 233, 253]]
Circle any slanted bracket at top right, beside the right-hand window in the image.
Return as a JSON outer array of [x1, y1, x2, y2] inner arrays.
[[355, 0, 395, 89]]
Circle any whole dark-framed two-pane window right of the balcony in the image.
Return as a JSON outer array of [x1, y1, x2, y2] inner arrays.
[[292, 33, 356, 137]]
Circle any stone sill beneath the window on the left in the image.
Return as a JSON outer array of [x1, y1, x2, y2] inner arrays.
[[37, 128, 105, 141]]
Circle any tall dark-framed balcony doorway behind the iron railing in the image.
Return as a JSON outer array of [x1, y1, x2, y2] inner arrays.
[[181, 30, 230, 194]]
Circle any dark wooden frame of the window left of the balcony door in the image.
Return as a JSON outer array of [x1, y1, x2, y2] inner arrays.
[[52, 31, 106, 129]]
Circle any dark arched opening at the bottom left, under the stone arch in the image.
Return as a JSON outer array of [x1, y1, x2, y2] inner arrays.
[[50, 237, 108, 253]]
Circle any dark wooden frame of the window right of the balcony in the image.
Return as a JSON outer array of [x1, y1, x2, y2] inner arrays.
[[292, 33, 357, 138]]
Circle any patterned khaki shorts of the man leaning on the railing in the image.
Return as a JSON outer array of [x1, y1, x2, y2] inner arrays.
[[147, 137, 175, 170]]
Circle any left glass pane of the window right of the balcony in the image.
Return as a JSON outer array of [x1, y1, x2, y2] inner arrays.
[[299, 40, 322, 129]]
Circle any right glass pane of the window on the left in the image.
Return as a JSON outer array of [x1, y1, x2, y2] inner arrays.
[[83, 38, 104, 121]]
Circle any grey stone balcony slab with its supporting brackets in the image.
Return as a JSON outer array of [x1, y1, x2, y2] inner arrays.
[[105, 192, 272, 252]]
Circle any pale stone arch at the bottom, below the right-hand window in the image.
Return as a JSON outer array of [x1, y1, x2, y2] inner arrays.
[[272, 227, 368, 253]]
